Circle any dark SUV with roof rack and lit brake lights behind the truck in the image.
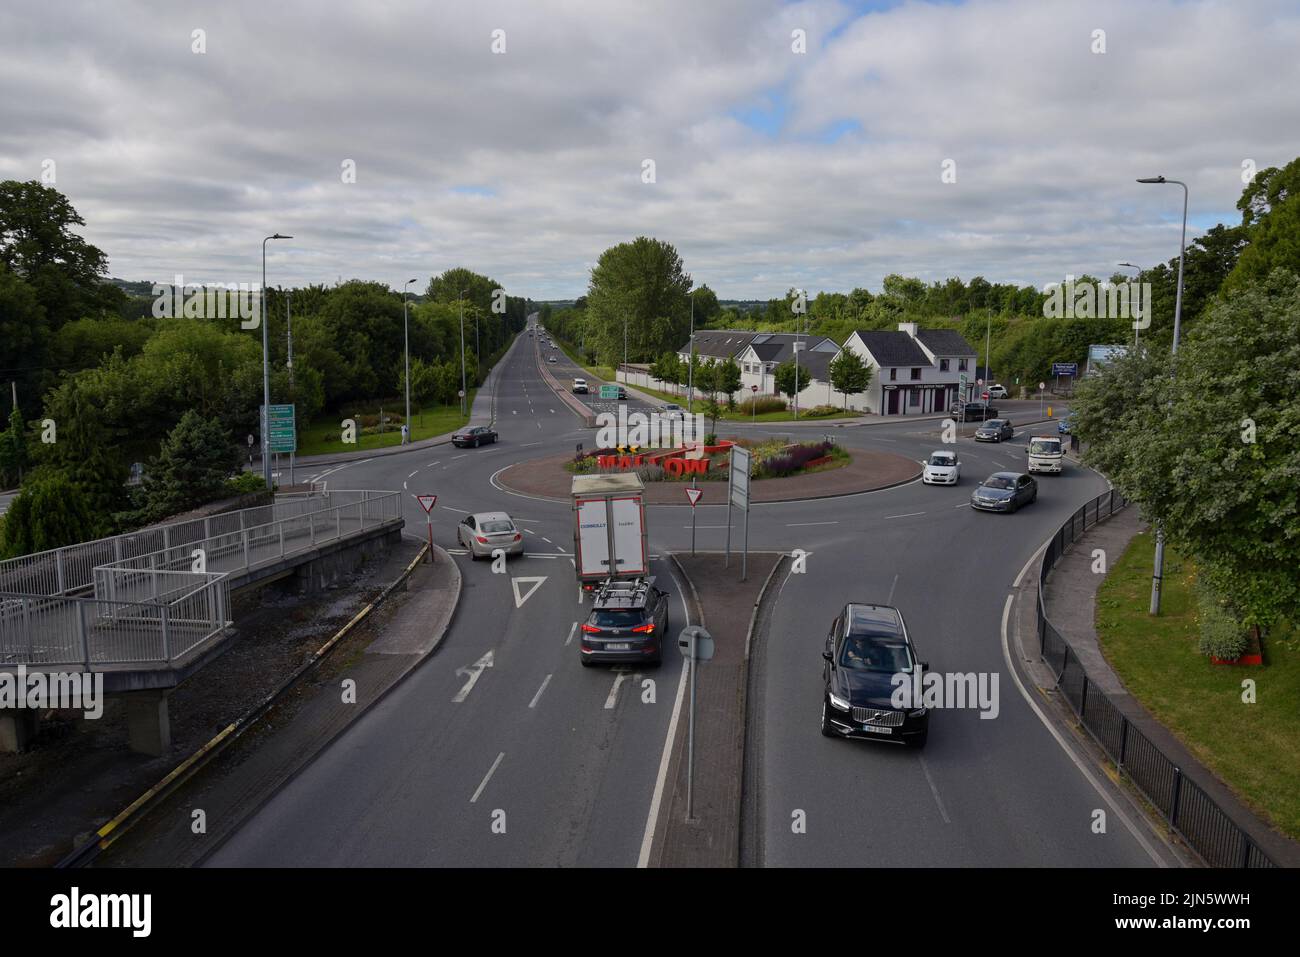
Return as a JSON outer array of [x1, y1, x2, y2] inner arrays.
[[580, 577, 668, 667]]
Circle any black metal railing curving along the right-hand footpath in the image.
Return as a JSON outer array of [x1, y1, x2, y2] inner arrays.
[[1037, 490, 1277, 867]]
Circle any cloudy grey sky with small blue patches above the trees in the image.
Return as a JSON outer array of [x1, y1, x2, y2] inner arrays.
[[0, 0, 1300, 299]]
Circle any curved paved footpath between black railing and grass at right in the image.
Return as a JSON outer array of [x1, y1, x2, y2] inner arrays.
[[1034, 506, 1300, 867]]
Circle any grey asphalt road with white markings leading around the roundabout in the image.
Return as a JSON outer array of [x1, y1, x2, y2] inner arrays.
[[209, 319, 1173, 867]]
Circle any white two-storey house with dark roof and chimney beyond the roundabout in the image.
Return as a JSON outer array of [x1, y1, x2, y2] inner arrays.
[[844, 322, 975, 415]]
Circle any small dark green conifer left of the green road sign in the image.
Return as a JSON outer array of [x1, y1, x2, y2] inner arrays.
[[142, 410, 239, 521]]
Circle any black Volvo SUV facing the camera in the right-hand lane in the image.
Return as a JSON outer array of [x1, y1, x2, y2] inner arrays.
[[822, 602, 930, 748]]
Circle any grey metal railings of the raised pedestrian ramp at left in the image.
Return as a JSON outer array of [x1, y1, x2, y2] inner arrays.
[[0, 490, 402, 668]]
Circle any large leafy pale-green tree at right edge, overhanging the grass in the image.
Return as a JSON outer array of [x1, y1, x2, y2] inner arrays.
[[1073, 269, 1300, 627]]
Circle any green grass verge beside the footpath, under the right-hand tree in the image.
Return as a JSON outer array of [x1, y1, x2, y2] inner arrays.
[[1096, 533, 1300, 839]]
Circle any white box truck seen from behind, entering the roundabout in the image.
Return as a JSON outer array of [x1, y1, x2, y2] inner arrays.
[[572, 473, 650, 589]]
